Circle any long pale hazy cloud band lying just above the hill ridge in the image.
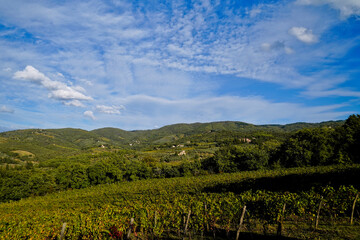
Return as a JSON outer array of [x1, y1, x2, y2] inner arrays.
[[98, 95, 350, 129]]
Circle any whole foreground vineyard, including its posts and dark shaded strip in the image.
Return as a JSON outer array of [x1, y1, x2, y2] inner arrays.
[[0, 165, 360, 239]]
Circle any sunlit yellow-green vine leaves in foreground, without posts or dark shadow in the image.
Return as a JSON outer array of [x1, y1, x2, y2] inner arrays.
[[0, 165, 360, 239]]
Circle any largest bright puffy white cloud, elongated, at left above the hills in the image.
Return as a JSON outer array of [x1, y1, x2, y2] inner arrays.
[[13, 66, 92, 106]]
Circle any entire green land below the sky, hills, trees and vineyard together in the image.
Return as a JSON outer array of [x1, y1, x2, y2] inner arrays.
[[0, 115, 360, 239]]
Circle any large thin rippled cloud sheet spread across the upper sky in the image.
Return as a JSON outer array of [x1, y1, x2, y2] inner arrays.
[[1, 2, 356, 90]]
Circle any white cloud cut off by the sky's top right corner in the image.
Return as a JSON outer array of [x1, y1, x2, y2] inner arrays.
[[296, 0, 360, 18]]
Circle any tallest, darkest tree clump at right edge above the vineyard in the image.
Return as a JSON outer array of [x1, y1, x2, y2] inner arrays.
[[275, 115, 360, 167]]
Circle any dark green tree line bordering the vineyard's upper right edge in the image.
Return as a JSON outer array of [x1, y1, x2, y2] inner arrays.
[[202, 115, 360, 173]]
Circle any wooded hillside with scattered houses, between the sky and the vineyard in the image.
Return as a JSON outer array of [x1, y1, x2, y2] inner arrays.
[[0, 115, 359, 201]]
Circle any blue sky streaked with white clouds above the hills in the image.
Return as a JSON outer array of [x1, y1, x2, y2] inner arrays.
[[0, 0, 360, 130]]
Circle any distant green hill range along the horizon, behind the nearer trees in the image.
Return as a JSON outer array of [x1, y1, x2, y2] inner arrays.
[[0, 121, 344, 160]]
